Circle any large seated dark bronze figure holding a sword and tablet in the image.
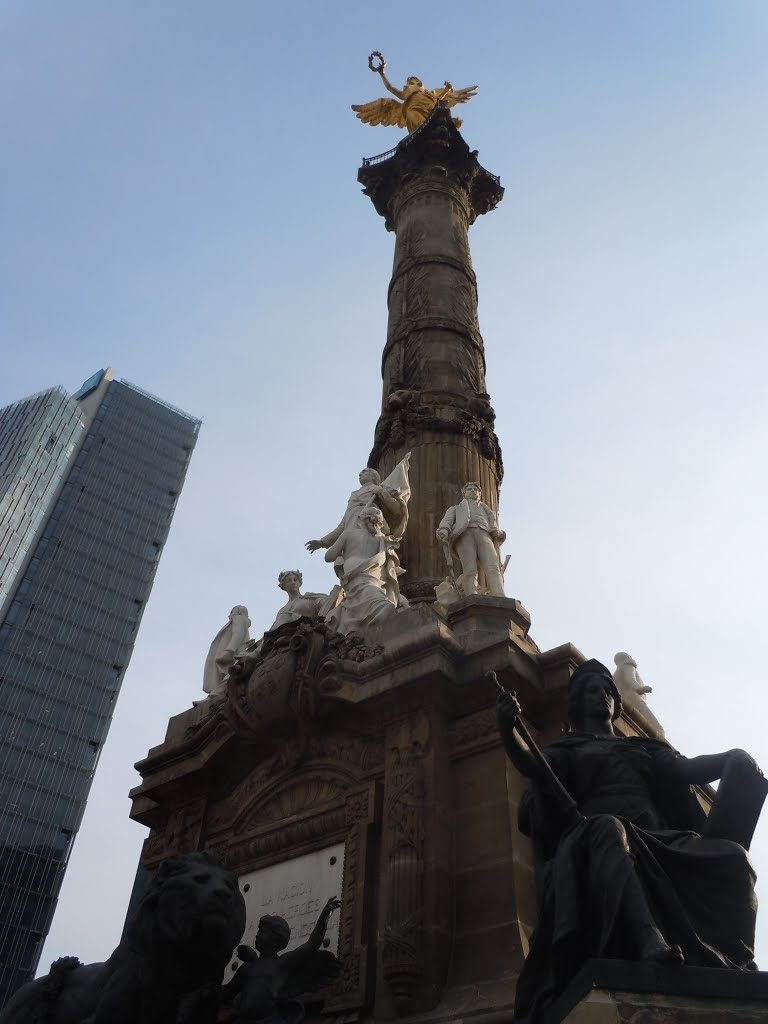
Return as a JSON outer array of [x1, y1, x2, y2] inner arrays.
[[497, 660, 766, 1024]]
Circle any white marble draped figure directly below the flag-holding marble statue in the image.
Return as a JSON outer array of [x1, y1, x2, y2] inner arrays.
[[326, 505, 408, 633]]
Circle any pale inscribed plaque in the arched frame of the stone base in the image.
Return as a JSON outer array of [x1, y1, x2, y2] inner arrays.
[[233, 843, 344, 953]]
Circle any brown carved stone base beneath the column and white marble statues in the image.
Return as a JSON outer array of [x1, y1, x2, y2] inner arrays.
[[132, 597, 582, 1021]]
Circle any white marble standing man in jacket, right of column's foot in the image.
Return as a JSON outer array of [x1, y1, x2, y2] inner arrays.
[[435, 481, 507, 597]]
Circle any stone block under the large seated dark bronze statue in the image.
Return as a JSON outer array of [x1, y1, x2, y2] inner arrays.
[[546, 961, 768, 1024]]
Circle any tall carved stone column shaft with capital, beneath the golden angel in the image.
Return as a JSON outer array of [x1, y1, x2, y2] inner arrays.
[[357, 104, 504, 600]]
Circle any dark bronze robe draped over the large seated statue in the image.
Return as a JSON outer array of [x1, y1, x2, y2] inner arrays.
[[515, 734, 757, 1024]]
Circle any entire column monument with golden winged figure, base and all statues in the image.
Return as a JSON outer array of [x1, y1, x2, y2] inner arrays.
[[9, 52, 768, 1024]]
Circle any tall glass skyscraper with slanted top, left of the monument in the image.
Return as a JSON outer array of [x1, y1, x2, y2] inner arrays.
[[0, 371, 200, 1007]]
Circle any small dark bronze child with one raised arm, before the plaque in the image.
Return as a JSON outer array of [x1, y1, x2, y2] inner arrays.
[[221, 896, 341, 1024]]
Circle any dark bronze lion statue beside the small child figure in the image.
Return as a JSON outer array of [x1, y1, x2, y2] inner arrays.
[[0, 853, 246, 1024]]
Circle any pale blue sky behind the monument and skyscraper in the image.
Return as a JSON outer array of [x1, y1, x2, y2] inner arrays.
[[0, 0, 768, 966]]
